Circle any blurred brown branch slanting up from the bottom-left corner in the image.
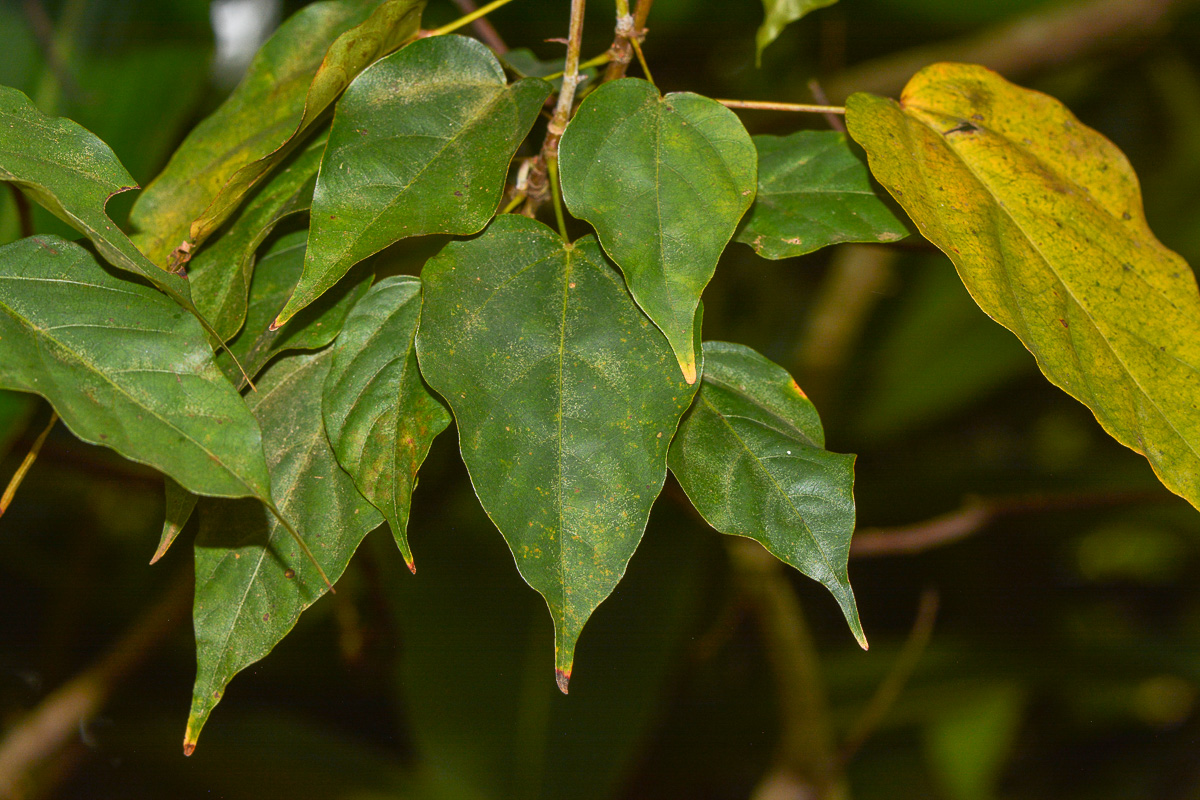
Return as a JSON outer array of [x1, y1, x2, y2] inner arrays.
[[0, 564, 192, 800]]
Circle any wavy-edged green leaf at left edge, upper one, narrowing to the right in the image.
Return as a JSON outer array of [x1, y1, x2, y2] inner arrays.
[[0, 86, 193, 309]]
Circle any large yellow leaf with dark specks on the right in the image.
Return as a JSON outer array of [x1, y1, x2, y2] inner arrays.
[[847, 64, 1200, 507]]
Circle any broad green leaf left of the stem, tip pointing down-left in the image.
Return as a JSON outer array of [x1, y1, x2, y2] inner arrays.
[[278, 36, 550, 324]]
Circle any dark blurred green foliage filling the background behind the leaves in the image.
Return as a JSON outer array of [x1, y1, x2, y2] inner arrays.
[[0, 0, 1200, 800]]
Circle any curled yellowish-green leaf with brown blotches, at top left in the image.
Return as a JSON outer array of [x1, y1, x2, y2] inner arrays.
[[130, 0, 425, 267]]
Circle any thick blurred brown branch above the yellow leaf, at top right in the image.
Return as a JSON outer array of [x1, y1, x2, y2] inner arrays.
[[824, 0, 1180, 101]]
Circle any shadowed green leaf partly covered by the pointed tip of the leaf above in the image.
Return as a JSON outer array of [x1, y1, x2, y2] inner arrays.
[[217, 230, 374, 381]]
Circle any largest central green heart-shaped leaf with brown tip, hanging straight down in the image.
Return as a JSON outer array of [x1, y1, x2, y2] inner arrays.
[[416, 215, 695, 691]]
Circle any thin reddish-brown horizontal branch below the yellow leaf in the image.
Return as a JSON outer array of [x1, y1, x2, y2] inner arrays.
[[850, 491, 1175, 558]]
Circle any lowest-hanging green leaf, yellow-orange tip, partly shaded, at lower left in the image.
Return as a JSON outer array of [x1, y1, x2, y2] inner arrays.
[[184, 349, 383, 753]]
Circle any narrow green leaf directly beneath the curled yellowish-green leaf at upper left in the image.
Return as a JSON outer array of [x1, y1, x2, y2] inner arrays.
[[187, 137, 325, 341]]
